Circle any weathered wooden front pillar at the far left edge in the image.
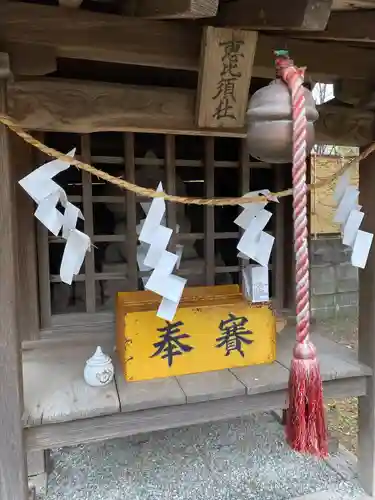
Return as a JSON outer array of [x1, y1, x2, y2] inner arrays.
[[0, 53, 28, 500]]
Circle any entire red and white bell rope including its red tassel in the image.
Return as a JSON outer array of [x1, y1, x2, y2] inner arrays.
[[276, 51, 328, 456]]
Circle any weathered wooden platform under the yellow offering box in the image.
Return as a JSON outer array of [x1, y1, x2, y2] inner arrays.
[[23, 329, 371, 450]]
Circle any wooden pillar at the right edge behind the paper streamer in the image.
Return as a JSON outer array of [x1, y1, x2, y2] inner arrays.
[[358, 144, 375, 496]]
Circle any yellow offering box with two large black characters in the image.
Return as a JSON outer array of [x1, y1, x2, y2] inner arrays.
[[116, 285, 276, 382]]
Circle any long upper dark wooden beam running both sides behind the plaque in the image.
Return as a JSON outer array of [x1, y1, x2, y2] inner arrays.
[[0, 2, 375, 81]]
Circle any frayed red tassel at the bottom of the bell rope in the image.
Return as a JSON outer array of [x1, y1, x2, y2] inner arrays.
[[286, 342, 328, 457]]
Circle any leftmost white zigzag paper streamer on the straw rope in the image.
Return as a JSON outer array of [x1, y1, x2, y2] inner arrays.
[[19, 149, 91, 285]]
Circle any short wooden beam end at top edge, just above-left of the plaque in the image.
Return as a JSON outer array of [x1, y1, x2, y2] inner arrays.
[[123, 0, 219, 19]]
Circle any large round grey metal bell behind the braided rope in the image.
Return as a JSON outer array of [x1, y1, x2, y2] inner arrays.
[[246, 79, 319, 163]]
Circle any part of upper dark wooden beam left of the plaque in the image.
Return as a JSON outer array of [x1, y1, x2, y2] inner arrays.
[[0, 2, 202, 71]]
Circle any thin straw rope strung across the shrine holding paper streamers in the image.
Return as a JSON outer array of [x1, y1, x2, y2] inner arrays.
[[0, 115, 375, 206]]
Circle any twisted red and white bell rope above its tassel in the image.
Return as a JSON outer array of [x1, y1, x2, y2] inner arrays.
[[276, 59, 315, 348]]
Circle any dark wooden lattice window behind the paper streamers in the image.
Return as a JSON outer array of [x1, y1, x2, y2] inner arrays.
[[37, 133, 284, 329]]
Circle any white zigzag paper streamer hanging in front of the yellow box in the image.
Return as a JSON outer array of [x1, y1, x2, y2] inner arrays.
[[138, 183, 187, 321]]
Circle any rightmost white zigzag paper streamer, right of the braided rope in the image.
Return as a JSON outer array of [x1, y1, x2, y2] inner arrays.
[[333, 170, 374, 269]]
